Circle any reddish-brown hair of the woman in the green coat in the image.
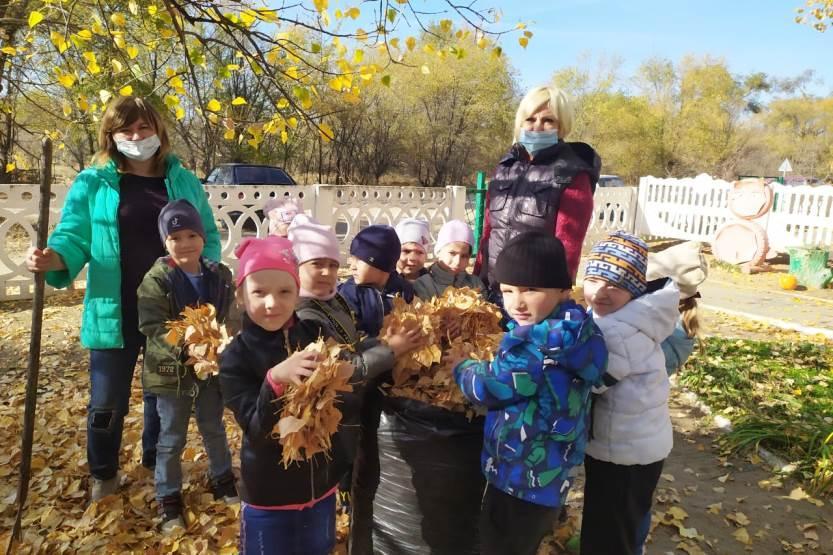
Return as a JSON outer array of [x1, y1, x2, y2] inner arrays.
[[95, 96, 171, 171]]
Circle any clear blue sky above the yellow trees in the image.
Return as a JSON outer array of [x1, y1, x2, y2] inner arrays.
[[488, 0, 833, 95]]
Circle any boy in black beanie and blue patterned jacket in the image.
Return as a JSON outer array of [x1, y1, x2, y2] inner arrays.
[[454, 232, 607, 555]]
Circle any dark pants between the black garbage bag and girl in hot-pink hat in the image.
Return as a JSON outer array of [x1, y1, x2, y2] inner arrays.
[[350, 386, 384, 555]]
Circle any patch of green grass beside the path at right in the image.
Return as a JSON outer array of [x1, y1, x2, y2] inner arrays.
[[680, 337, 833, 494]]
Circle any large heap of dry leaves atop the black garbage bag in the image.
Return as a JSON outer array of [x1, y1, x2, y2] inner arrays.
[[385, 287, 503, 415]]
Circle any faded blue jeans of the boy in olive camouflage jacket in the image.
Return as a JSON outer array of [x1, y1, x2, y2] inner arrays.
[[154, 377, 231, 499]]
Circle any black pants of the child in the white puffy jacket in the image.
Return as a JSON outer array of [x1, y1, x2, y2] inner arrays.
[[581, 456, 665, 555]]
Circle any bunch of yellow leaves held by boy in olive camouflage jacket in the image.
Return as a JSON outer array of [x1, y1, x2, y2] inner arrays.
[[165, 303, 231, 380]]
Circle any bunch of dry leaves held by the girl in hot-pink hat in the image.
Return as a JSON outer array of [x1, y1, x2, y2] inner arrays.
[[272, 339, 354, 468]]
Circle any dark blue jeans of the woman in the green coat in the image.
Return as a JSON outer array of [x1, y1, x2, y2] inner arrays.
[[87, 336, 159, 480]]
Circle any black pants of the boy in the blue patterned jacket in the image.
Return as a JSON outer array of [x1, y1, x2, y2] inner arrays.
[[480, 484, 560, 555]]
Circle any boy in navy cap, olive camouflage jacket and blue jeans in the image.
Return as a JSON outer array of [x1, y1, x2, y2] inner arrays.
[[138, 200, 239, 533]]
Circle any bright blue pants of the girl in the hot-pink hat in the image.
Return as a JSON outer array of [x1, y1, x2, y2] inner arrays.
[[240, 496, 336, 555]]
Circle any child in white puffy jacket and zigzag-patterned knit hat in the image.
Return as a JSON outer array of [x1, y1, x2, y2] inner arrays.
[[581, 231, 680, 555]]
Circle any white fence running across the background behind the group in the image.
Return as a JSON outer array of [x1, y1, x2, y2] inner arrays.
[[0, 176, 833, 300]]
